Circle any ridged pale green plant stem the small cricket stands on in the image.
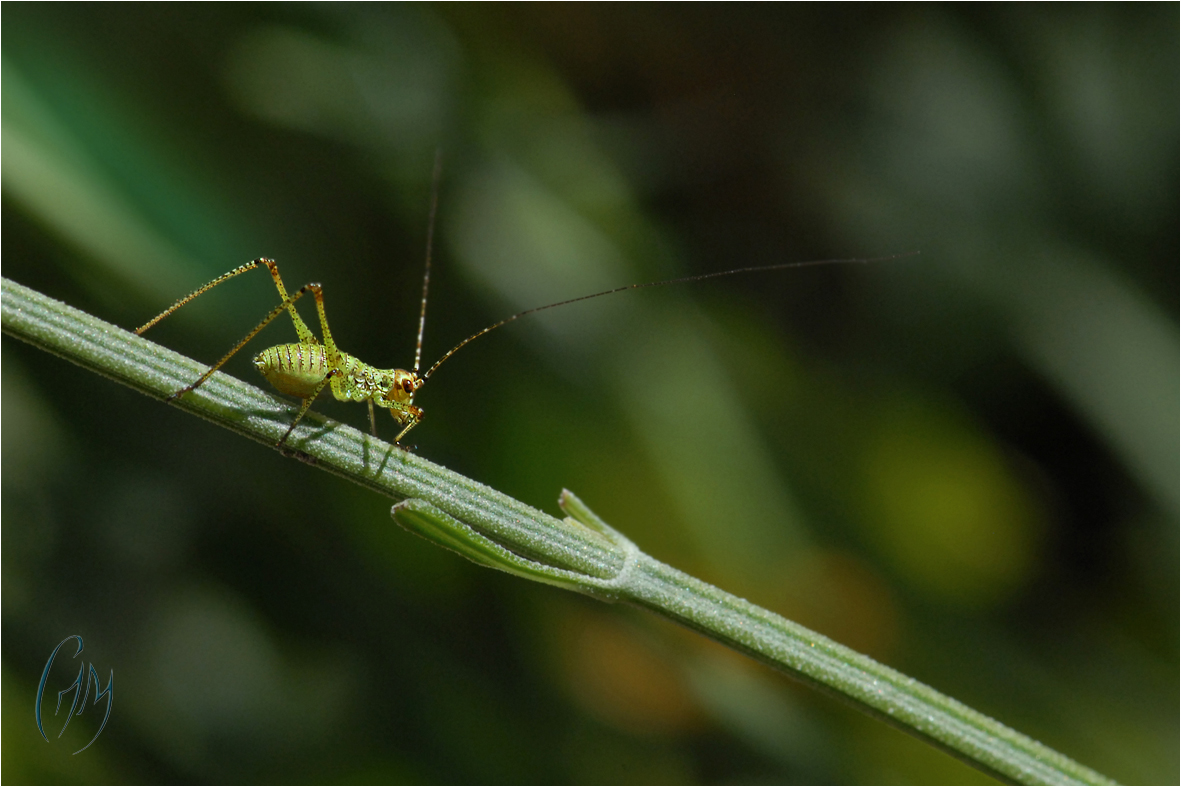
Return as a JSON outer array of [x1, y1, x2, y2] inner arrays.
[[2, 279, 1109, 783]]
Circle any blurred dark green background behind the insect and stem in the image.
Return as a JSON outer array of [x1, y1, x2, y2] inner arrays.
[[0, 4, 1181, 782]]
